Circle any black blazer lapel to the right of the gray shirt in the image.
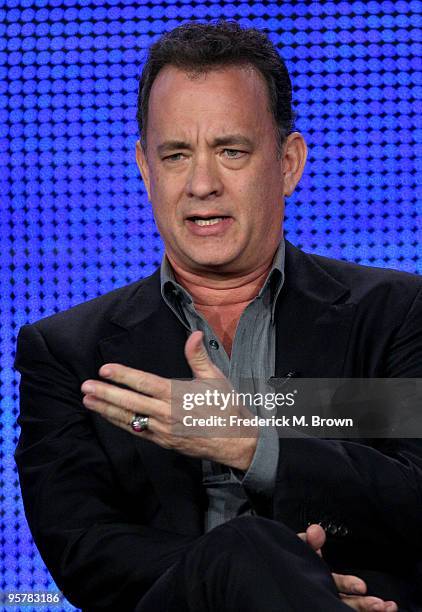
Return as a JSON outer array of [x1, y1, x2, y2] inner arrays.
[[275, 241, 355, 378]]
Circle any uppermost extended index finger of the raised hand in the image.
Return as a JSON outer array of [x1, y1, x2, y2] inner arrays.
[[98, 363, 171, 399]]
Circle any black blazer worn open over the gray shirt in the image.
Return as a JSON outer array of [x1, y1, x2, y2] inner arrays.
[[16, 243, 422, 611]]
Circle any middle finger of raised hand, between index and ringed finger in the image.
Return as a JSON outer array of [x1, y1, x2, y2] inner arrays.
[[81, 380, 168, 418]]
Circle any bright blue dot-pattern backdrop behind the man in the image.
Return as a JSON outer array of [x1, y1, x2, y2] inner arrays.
[[0, 0, 422, 611]]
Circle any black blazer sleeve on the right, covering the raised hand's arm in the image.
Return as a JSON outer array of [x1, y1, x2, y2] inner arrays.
[[270, 290, 422, 571]]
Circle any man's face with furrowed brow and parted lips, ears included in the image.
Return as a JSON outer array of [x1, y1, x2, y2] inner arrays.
[[137, 66, 306, 275]]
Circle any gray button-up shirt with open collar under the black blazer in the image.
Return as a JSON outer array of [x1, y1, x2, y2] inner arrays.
[[161, 240, 285, 531]]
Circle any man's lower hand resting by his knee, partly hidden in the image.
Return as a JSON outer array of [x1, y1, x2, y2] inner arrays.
[[298, 525, 398, 612]]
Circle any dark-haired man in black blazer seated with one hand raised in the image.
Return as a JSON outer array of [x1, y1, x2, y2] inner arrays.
[[16, 23, 422, 612]]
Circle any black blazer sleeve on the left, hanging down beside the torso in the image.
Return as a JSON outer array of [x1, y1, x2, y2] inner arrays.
[[15, 325, 195, 611]]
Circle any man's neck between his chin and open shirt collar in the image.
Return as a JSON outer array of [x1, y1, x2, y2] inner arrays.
[[167, 254, 274, 306]]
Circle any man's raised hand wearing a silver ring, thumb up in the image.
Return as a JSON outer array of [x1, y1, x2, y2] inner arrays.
[[81, 332, 258, 471]]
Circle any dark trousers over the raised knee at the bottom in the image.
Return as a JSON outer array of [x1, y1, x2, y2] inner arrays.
[[135, 516, 350, 612]]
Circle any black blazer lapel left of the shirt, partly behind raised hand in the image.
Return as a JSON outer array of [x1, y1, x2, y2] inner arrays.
[[98, 271, 204, 535]]
